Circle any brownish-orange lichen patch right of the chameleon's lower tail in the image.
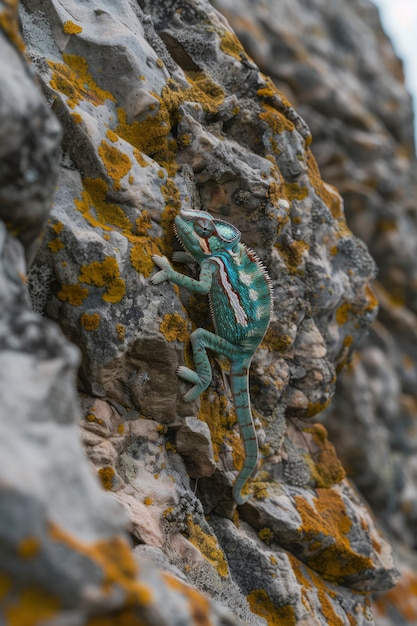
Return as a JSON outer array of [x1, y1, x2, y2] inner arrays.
[[302, 424, 346, 488]]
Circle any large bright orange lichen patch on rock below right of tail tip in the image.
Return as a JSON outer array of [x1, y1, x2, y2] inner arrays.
[[294, 488, 373, 583]]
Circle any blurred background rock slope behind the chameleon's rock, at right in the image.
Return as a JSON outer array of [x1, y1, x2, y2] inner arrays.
[[213, 0, 417, 626]]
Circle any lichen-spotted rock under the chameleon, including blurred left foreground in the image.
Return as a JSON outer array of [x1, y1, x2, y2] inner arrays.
[[0, 0, 404, 626]]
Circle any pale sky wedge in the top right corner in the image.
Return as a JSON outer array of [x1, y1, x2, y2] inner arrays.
[[373, 0, 417, 142]]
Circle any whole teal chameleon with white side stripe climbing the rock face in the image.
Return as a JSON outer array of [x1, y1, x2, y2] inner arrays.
[[151, 210, 272, 504]]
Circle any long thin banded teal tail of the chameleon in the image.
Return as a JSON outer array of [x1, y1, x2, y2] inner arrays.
[[230, 363, 258, 504]]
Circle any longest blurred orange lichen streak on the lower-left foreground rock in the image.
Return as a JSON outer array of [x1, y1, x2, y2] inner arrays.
[[49, 523, 152, 604]]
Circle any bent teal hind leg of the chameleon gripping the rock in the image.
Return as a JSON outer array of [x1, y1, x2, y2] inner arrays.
[[177, 328, 239, 402]]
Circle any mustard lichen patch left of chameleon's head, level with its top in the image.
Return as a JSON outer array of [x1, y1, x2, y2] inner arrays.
[[74, 178, 132, 235]]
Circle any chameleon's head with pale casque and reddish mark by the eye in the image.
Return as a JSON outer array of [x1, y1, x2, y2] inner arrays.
[[174, 210, 240, 261]]
